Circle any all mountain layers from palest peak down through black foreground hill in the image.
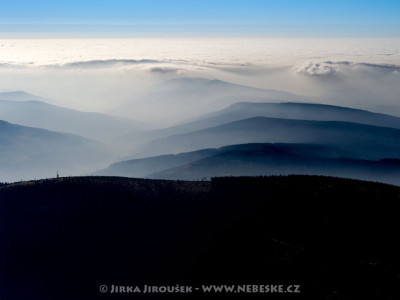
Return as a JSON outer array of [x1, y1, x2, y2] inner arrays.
[[0, 78, 400, 300]]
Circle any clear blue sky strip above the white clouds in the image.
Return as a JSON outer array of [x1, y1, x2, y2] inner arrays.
[[0, 0, 400, 38]]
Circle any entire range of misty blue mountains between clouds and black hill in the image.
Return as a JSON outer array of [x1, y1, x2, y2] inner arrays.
[[0, 82, 400, 184]]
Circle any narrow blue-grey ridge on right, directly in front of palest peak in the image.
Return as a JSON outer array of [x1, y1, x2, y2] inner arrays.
[[115, 102, 400, 152]]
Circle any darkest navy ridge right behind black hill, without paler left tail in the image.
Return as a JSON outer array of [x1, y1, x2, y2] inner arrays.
[[148, 144, 400, 185]]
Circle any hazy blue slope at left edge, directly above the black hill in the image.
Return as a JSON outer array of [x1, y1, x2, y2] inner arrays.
[[0, 121, 113, 181]]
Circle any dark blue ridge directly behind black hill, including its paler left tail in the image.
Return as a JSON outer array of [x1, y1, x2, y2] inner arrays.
[[95, 144, 400, 185]]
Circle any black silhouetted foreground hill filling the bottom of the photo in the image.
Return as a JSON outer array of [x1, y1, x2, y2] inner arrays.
[[0, 176, 400, 300]]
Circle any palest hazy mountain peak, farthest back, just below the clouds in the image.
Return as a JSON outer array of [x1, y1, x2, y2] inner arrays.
[[110, 78, 303, 126]]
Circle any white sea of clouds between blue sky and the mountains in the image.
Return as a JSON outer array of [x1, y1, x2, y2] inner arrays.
[[0, 38, 400, 115]]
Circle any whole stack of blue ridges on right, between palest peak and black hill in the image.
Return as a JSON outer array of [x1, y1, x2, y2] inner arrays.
[[104, 95, 400, 184]]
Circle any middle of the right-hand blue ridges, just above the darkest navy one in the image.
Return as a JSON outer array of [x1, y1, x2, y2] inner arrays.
[[139, 117, 400, 160]]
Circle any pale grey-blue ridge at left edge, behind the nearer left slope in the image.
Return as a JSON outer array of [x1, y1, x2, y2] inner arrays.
[[0, 95, 143, 141]]
